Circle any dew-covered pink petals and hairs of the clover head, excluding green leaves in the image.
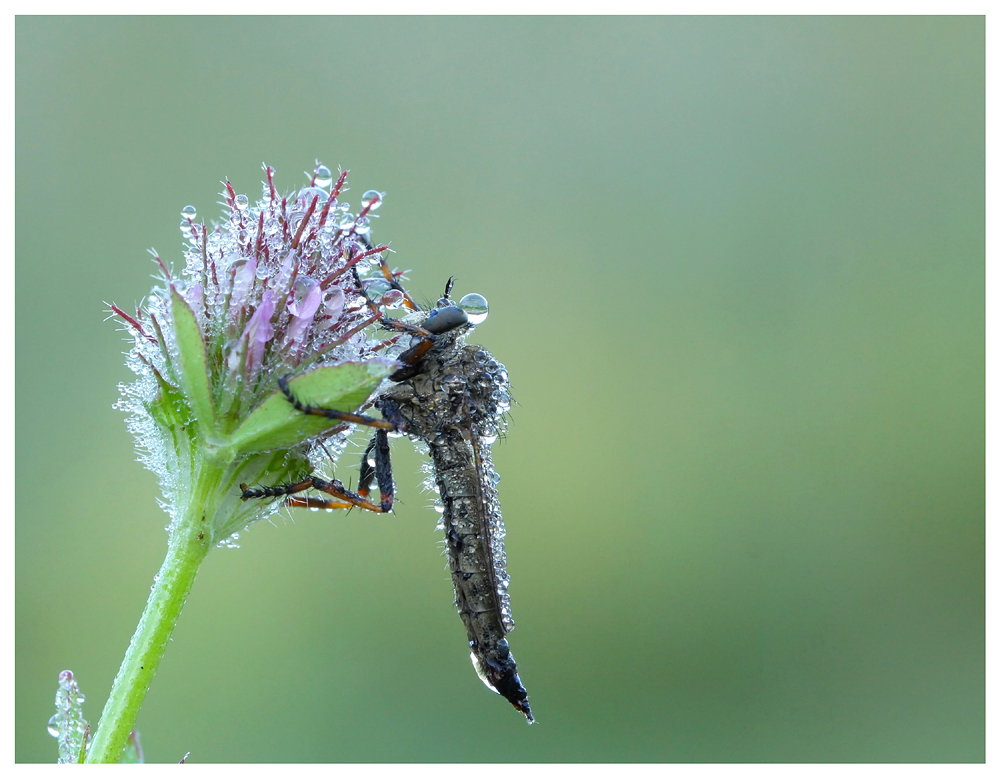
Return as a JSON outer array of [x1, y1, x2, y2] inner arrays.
[[112, 163, 405, 542]]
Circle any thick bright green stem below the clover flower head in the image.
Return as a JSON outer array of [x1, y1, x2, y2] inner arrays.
[[87, 466, 222, 763]]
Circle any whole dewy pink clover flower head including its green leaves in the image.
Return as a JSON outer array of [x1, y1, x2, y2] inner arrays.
[[112, 163, 404, 542]]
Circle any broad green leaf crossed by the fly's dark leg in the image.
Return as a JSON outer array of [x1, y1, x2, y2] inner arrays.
[[229, 359, 399, 454]]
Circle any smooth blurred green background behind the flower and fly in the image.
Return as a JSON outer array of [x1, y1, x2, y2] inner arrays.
[[15, 17, 985, 762]]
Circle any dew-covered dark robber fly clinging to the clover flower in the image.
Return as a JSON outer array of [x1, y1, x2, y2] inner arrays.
[[240, 263, 534, 723]]
